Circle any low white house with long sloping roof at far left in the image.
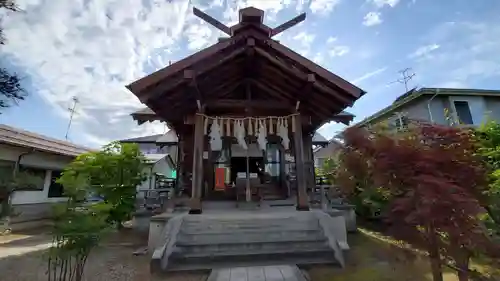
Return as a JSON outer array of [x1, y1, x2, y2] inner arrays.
[[0, 124, 90, 224]]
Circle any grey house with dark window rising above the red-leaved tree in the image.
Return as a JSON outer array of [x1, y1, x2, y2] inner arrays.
[[354, 88, 500, 128]]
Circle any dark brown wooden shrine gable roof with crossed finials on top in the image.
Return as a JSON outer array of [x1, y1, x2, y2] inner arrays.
[[127, 5, 365, 129]]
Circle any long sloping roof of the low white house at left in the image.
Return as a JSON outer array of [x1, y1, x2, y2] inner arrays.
[[0, 124, 92, 157]]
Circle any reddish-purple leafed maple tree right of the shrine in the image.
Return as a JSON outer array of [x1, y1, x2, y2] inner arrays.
[[341, 124, 498, 281]]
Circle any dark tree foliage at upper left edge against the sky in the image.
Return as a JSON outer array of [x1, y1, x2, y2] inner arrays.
[[0, 0, 26, 110]]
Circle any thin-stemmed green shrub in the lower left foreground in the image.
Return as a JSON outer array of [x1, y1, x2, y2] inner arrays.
[[47, 174, 111, 281]]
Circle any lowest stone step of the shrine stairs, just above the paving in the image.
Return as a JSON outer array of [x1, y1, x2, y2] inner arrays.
[[167, 250, 338, 271]]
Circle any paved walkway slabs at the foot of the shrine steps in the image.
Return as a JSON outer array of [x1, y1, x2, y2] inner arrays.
[[208, 265, 306, 281]]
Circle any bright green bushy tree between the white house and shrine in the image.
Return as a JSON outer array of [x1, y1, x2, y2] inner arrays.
[[61, 142, 146, 227]]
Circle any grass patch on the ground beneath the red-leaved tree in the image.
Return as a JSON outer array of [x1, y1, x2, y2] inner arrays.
[[309, 229, 500, 281]]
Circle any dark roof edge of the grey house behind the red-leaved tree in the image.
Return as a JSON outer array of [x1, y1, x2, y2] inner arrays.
[[353, 88, 500, 126]]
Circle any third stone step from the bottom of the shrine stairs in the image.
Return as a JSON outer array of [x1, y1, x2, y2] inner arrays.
[[177, 230, 325, 245]]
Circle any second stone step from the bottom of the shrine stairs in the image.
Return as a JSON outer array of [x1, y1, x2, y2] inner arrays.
[[174, 238, 331, 257]]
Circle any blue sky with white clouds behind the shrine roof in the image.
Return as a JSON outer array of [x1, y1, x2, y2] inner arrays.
[[0, 0, 500, 147]]
